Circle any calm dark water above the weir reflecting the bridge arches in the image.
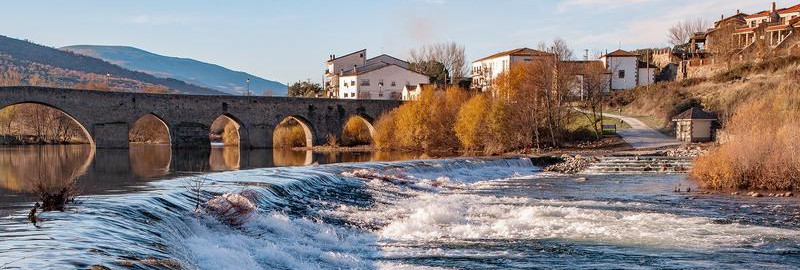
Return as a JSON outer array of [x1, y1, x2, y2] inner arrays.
[[0, 145, 428, 216]]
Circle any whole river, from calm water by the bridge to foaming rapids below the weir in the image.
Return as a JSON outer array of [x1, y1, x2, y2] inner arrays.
[[0, 147, 800, 269]]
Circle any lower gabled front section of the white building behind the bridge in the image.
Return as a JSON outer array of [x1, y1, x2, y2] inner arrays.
[[338, 63, 429, 100]]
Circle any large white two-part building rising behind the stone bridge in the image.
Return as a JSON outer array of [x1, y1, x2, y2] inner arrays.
[[324, 50, 430, 100]]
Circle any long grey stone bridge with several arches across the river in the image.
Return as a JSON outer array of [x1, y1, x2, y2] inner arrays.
[[0, 86, 402, 148]]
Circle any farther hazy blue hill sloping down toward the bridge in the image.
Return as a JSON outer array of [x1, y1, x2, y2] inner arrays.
[[61, 45, 287, 96]]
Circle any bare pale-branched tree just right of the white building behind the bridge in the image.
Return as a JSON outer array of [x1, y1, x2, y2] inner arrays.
[[409, 42, 467, 83]]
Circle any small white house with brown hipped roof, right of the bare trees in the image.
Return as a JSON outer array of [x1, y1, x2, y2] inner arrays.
[[600, 50, 655, 90]]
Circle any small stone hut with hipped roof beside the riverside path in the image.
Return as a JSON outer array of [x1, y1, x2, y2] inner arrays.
[[672, 107, 717, 142]]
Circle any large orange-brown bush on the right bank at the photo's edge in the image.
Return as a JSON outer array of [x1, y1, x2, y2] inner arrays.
[[691, 83, 800, 189]]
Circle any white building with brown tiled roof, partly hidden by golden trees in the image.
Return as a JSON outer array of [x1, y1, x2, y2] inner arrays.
[[471, 48, 555, 91]]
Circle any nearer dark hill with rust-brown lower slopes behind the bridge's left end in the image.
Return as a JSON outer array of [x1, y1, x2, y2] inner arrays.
[[0, 35, 224, 95]]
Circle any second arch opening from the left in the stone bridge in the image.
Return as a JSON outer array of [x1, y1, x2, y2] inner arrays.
[[128, 113, 172, 144]]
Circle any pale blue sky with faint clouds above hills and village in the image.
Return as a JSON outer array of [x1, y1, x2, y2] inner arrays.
[[0, 0, 797, 84]]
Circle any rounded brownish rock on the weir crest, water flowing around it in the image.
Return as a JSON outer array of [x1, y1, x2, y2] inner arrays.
[[206, 192, 256, 226]]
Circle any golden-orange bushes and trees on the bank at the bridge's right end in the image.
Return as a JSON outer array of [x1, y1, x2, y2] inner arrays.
[[375, 57, 594, 154]]
